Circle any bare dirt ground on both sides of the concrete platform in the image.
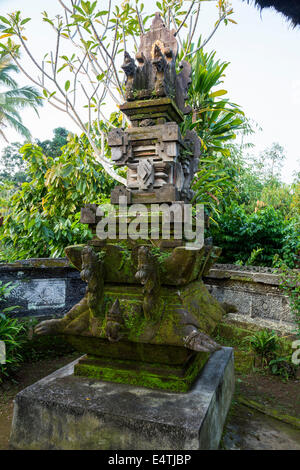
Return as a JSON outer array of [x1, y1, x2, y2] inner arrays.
[[0, 353, 300, 450]]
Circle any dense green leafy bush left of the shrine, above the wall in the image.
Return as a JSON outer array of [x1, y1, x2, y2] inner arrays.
[[1, 130, 114, 260]]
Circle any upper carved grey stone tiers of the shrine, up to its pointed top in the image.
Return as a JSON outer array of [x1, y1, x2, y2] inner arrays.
[[108, 13, 200, 203]]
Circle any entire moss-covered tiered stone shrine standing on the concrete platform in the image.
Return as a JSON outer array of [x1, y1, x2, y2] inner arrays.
[[36, 14, 224, 392]]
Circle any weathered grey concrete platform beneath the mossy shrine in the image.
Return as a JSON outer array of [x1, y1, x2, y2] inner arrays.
[[11, 348, 234, 450]]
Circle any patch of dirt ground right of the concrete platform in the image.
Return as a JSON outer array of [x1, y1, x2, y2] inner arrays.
[[220, 373, 300, 450]]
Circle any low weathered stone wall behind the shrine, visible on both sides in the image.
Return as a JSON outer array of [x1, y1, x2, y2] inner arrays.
[[0, 258, 295, 333]]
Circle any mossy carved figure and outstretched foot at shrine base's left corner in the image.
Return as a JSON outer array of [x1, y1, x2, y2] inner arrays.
[[35, 246, 104, 335]]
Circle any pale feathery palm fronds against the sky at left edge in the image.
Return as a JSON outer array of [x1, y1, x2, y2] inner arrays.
[[0, 52, 43, 142]]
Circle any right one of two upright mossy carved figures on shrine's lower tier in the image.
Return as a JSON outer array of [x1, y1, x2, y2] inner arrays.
[[135, 246, 160, 321]]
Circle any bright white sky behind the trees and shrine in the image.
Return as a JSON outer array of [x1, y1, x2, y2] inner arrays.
[[0, 0, 300, 182]]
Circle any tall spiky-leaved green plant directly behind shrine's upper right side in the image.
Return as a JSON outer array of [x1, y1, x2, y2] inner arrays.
[[182, 46, 245, 214]]
